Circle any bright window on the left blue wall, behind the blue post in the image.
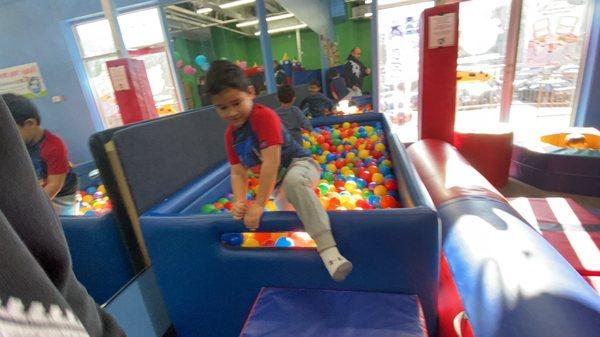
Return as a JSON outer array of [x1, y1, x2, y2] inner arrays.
[[73, 8, 181, 128]]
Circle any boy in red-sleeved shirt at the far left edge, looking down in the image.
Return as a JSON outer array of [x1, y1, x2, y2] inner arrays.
[[2, 94, 79, 215]]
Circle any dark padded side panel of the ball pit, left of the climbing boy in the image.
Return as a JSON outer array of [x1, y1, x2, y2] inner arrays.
[[112, 107, 226, 214]]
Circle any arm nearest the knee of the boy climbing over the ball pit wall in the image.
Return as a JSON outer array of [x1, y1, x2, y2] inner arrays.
[[244, 145, 281, 229]]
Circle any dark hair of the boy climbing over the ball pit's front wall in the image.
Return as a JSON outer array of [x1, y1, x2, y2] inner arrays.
[[206, 60, 248, 95]]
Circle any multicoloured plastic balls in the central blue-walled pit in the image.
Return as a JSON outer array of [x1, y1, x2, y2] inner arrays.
[[205, 122, 401, 248]]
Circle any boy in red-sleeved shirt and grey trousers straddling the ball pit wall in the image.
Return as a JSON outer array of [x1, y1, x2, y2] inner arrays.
[[206, 61, 352, 281]]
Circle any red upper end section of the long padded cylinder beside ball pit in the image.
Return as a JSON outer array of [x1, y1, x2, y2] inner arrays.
[[407, 139, 505, 205]]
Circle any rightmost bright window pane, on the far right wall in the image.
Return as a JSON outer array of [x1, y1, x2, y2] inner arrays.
[[510, 0, 589, 133]]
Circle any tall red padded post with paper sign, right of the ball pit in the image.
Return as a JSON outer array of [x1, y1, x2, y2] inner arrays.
[[419, 3, 458, 143]]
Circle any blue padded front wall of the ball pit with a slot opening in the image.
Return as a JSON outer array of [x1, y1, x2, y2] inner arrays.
[[141, 206, 440, 337]]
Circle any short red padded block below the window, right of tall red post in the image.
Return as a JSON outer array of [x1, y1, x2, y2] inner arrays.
[[454, 130, 513, 188]]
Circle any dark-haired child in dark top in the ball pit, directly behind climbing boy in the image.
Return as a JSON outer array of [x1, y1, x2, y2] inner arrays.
[[275, 84, 313, 145]]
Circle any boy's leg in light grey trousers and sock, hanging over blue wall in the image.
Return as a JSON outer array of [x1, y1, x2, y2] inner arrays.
[[281, 158, 352, 281]]
